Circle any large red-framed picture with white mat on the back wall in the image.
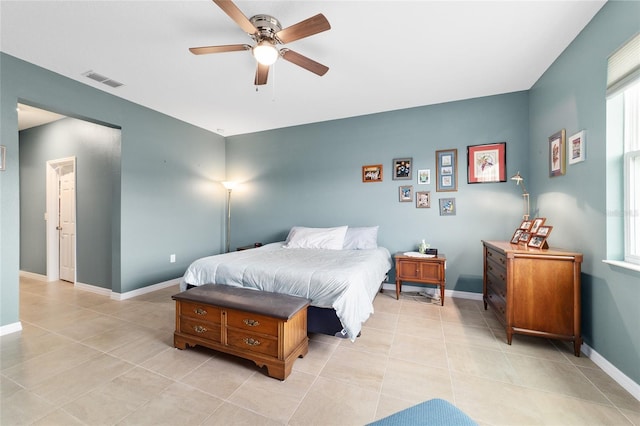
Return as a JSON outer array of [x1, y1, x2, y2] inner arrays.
[[467, 142, 507, 183]]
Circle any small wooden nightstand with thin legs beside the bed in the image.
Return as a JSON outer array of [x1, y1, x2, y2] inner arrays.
[[395, 253, 447, 306]]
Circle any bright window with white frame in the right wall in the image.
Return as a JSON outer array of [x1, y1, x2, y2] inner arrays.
[[607, 34, 640, 270]]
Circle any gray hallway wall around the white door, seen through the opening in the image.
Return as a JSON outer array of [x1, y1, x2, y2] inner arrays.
[[19, 118, 120, 289]]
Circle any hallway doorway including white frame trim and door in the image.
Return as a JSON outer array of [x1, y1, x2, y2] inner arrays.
[[45, 157, 77, 283]]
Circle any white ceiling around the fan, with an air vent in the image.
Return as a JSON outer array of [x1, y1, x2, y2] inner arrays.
[[0, 0, 605, 136]]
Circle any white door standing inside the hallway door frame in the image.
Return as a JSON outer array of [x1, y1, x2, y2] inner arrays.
[[58, 167, 76, 282]]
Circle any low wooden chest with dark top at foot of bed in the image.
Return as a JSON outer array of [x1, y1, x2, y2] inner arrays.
[[173, 284, 310, 380]]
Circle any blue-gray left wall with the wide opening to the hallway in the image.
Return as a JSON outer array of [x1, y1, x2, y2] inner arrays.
[[0, 53, 225, 326]]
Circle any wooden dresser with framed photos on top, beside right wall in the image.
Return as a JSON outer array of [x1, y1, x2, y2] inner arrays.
[[482, 241, 582, 356]]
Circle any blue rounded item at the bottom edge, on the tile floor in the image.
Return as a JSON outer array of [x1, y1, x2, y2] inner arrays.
[[369, 399, 477, 426]]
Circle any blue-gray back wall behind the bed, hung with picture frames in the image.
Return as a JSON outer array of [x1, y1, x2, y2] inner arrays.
[[227, 92, 529, 292]]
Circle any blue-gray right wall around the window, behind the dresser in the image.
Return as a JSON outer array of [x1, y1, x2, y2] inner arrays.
[[528, 1, 640, 383]]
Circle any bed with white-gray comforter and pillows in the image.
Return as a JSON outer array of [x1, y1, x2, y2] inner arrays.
[[181, 227, 392, 341]]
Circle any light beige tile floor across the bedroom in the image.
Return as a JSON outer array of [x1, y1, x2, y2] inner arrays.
[[0, 278, 640, 426]]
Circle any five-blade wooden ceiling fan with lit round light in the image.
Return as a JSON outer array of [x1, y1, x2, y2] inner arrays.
[[189, 0, 331, 86]]
